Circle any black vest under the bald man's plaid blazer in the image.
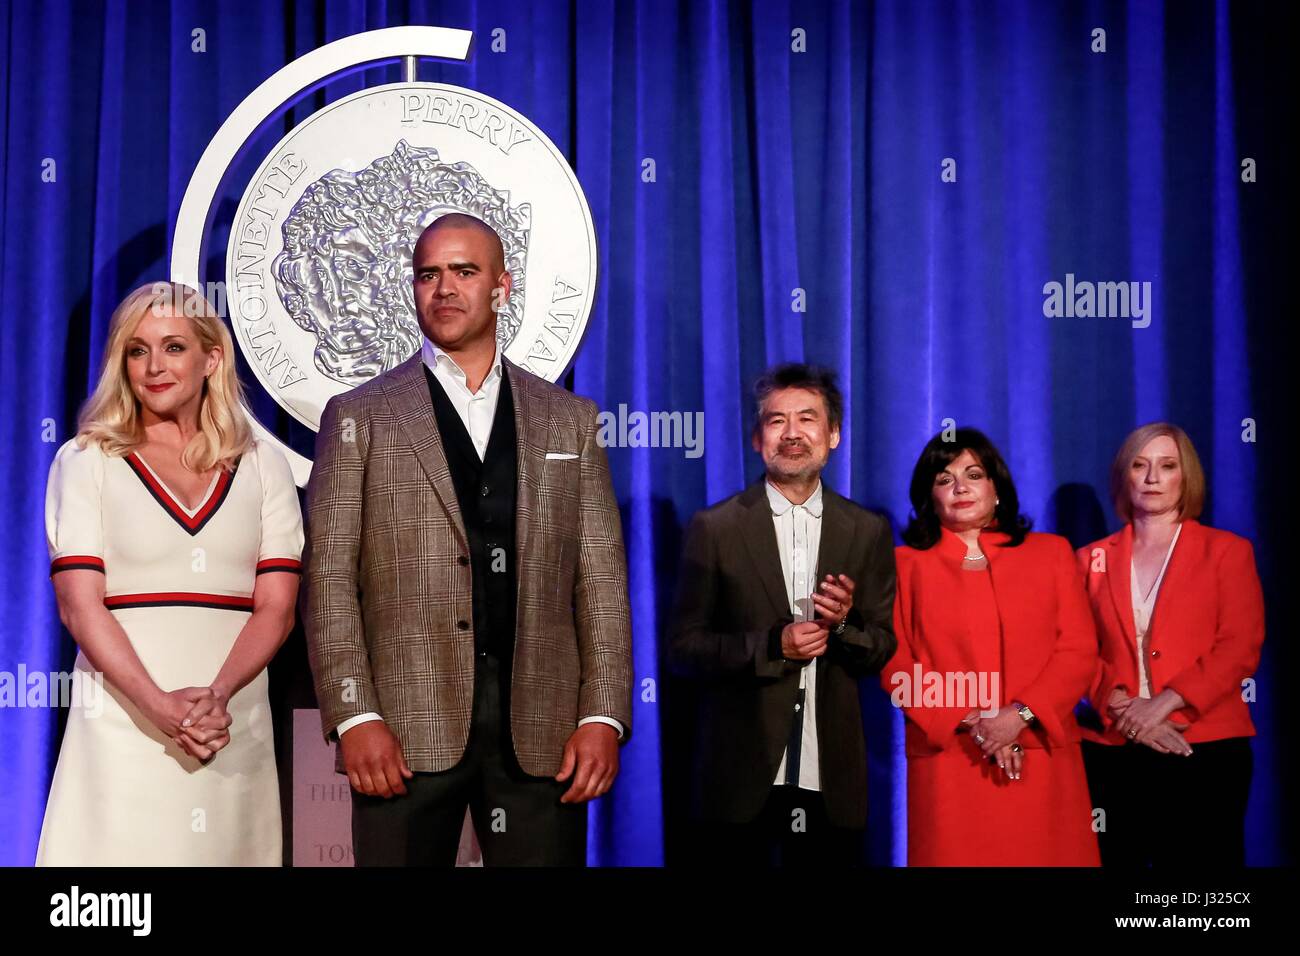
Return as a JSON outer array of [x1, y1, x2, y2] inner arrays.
[[424, 365, 519, 667]]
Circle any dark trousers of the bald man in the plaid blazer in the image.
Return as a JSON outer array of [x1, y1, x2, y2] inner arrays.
[[352, 654, 586, 866]]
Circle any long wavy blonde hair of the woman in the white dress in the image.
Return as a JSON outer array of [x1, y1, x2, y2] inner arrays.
[[77, 282, 254, 473]]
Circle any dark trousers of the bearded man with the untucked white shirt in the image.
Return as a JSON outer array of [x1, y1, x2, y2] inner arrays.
[[690, 786, 863, 869]]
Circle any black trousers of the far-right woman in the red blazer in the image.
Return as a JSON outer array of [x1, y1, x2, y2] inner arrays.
[[1083, 737, 1255, 868]]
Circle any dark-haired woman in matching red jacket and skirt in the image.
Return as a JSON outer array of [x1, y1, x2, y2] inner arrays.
[[881, 428, 1099, 866]]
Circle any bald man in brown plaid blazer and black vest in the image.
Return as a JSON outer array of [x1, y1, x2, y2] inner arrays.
[[304, 215, 632, 865]]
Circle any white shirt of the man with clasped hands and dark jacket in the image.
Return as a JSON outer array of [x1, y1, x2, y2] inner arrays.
[[767, 481, 822, 791]]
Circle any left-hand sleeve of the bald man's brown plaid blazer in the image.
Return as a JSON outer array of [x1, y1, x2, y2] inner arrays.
[[303, 397, 371, 740]]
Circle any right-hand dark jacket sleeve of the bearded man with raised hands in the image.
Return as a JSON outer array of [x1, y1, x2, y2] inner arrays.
[[827, 516, 898, 678]]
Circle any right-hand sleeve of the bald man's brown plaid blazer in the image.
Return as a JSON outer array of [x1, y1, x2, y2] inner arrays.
[[573, 402, 632, 743]]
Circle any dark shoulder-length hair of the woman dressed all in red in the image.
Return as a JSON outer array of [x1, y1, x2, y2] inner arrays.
[[902, 428, 1032, 551]]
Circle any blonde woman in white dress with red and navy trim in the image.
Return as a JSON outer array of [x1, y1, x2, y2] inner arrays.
[[36, 282, 303, 866]]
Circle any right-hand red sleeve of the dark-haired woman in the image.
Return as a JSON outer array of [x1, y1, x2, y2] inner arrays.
[[1015, 538, 1097, 744]]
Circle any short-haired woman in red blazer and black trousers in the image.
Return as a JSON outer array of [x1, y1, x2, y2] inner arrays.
[[1078, 423, 1264, 866]]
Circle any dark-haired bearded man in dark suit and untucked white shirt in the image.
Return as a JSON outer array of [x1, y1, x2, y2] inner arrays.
[[671, 364, 896, 865]]
